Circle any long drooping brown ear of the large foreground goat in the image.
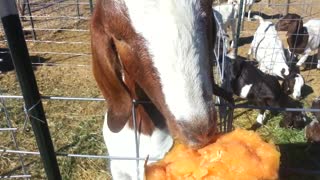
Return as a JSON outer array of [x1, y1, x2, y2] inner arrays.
[[91, 22, 132, 132]]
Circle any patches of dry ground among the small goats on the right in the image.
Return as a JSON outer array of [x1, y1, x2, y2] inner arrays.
[[235, 0, 320, 139]]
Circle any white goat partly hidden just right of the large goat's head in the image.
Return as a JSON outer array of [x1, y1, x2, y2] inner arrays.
[[213, 4, 237, 48]]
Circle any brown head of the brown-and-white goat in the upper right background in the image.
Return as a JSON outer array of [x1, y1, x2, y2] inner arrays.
[[276, 13, 303, 35]]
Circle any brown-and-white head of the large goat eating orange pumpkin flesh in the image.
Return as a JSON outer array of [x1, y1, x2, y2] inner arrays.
[[91, 0, 217, 148]]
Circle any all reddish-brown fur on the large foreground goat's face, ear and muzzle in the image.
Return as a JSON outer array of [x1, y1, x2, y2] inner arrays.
[[91, 0, 223, 146]]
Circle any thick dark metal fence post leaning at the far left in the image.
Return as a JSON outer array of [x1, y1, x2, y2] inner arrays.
[[0, 0, 61, 180]]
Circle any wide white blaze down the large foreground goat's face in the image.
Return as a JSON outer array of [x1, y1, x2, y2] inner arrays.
[[124, 0, 212, 121]]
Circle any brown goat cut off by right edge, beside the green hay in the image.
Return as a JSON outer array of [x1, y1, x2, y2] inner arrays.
[[305, 97, 320, 142]]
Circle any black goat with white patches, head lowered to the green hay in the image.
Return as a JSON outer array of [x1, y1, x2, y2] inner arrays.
[[229, 60, 305, 130]]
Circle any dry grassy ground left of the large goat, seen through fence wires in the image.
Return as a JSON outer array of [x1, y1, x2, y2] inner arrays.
[[0, 1, 110, 179]]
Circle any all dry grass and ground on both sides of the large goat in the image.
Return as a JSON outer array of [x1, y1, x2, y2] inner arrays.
[[0, 0, 320, 179]]
